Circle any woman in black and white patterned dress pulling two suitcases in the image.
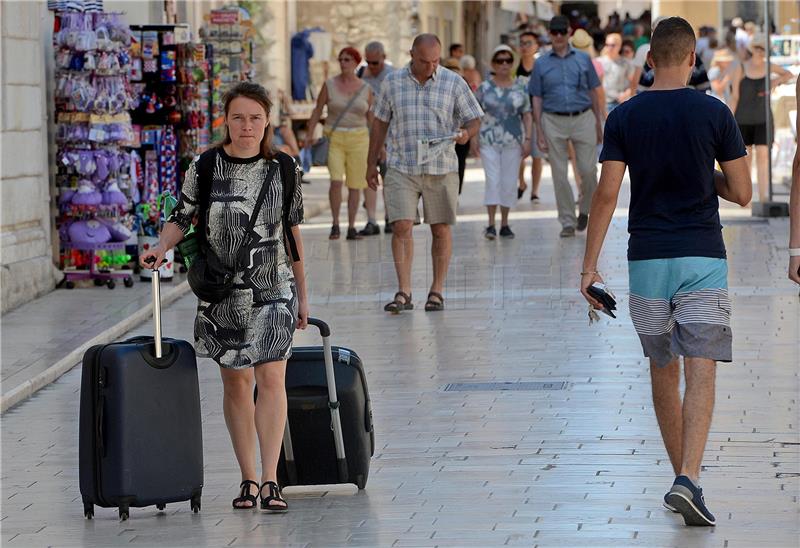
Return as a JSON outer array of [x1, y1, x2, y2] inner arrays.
[[141, 82, 308, 512]]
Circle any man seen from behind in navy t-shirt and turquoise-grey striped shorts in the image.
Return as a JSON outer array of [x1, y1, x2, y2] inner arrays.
[[581, 17, 752, 525]]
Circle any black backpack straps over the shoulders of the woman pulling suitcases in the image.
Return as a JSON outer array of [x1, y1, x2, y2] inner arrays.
[[195, 147, 300, 262]]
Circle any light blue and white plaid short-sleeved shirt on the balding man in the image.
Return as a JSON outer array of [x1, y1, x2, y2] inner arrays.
[[372, 65, 483, 175]]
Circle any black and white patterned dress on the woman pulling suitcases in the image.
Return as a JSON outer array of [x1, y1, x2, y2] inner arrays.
[[169, 148, 303, 369]]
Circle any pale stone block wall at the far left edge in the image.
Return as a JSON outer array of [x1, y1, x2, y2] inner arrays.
[[0, 0, 59, 312]]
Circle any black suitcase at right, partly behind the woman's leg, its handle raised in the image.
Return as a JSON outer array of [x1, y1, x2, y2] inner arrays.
[[256, 318, 375, 489]]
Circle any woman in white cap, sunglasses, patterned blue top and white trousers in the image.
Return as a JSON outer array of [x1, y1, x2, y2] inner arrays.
[[473, 45, 532, 240]]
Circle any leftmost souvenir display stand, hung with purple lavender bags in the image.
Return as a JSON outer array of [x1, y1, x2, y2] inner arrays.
[[53, 11, 136, 289]]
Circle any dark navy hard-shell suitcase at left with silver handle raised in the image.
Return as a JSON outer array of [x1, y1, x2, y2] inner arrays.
[[79, 270, 203, 520]]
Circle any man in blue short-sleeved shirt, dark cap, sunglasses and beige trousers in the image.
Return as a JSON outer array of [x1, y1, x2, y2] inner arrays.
[[528, 15, 603, 238]]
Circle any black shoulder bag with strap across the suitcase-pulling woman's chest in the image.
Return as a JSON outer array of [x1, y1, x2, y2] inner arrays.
[[188, 149, 276, 303]]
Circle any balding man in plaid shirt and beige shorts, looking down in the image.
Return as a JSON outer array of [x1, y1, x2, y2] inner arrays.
[[367, 34, 483, 314]]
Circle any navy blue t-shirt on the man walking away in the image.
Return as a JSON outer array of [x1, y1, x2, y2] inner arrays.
[[600, 88, 746, 261]]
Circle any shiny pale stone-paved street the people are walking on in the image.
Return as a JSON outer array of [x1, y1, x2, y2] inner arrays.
[[0, 161, 800, 548]]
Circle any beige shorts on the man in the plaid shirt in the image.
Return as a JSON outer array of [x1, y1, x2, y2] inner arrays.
[[383, 167, 458, 225]]
